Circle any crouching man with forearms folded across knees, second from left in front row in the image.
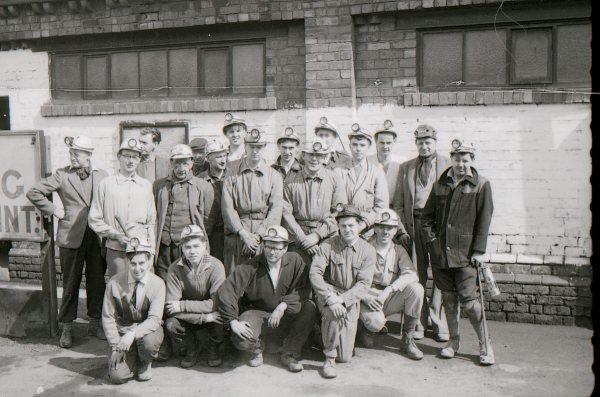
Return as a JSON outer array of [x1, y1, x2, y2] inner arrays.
[[165, 225, 225, 368]]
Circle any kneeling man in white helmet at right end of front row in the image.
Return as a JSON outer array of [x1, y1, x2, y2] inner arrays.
[[360, 209, 424, 360]]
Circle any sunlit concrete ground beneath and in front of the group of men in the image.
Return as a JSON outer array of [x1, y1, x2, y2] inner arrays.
[[0, 321, 594, 397]]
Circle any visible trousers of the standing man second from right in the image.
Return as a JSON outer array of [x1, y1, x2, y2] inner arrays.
[[414, 209, 448, 335]]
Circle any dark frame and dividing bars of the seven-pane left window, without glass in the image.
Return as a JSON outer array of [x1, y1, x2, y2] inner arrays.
[[50, 38, 267, 102]]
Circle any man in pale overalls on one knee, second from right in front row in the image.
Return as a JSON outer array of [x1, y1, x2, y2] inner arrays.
[[310, 204, 377, 378]]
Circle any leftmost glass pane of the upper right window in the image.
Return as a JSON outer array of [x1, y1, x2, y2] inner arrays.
[[421, 32, 463, 86]]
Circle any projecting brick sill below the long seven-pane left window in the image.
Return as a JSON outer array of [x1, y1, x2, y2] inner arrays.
[[41, 97, 277, 117]]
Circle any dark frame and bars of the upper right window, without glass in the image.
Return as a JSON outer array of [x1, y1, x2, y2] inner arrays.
[[416, 18, 591, 92]]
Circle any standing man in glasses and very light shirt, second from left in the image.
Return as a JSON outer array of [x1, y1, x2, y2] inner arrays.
[[88, 138, 156, 276]]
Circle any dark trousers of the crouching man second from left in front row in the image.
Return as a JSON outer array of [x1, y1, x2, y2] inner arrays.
[[165, 313, 224, 349]]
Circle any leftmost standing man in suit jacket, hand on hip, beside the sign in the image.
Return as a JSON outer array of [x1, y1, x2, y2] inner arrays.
[[27, 135, 108, 347]]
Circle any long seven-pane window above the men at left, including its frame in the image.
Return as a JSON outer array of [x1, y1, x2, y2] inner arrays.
[[51, 42, 265, 99]]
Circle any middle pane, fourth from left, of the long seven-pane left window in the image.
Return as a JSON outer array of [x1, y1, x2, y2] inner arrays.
[[140, 51, 168, 97]]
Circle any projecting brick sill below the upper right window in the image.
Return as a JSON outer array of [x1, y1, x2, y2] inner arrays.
[[402, 90, 590, 106]]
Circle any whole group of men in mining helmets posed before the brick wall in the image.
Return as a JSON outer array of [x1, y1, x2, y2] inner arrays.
[[27, 113, 494, 383]]
